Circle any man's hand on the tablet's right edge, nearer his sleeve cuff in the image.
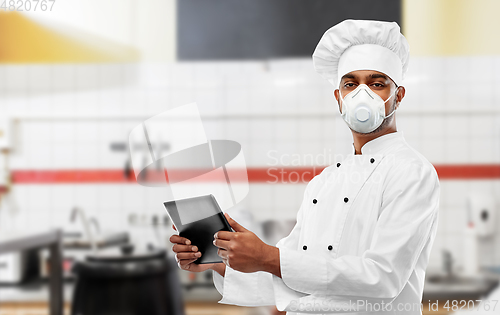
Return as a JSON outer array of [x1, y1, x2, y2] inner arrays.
[[214, 213, 281, 277]]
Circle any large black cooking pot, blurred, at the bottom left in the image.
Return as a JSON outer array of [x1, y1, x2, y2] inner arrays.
[[71, 246, 184, 315]]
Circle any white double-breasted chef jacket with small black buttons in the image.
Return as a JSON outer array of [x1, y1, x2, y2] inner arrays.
[[213, 132, 439, 315]]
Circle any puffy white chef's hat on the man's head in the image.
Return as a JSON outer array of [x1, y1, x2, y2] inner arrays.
[[313, 20, 410, 88]]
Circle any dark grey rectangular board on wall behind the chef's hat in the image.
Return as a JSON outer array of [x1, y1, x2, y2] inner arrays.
[[177, 0, 401, 60]]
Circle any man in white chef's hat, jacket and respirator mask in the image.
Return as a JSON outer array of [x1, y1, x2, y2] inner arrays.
[[170, 20, 439, 314]]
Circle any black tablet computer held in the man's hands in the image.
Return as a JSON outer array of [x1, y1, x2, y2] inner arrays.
[[163, 194, 233, 264]]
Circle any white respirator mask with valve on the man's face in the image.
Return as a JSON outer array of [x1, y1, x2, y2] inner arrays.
[[339, 84, 397, 133]]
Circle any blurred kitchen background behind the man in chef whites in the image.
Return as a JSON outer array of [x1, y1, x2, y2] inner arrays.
[[0, 0, 500, 315]]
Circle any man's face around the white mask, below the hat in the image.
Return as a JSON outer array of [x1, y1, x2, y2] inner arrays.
[[335, 70, 405, 133]]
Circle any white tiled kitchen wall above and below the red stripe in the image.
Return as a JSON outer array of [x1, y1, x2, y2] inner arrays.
[[0, 56, 500, 272]]
